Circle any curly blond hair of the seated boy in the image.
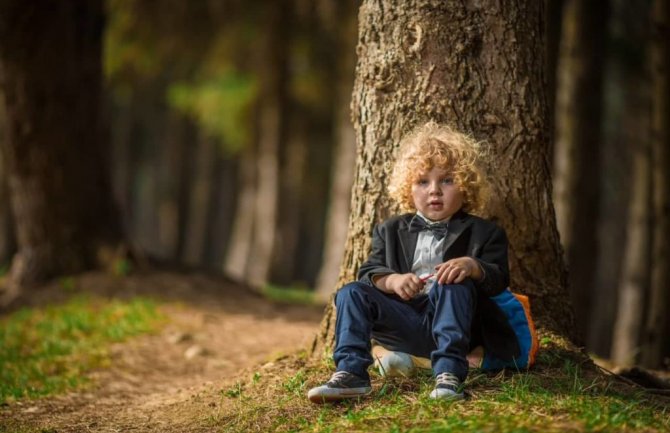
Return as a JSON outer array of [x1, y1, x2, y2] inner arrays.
[[389, 121, 489, 213]]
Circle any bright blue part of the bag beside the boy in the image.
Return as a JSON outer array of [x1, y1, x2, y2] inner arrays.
[[481, 289, 533, 370]]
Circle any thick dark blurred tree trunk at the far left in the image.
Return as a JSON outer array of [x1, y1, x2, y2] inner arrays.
[[0, 0, 122, 290]]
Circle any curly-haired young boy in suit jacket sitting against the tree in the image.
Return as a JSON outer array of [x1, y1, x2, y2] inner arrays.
[[308, 122, 519, 403]]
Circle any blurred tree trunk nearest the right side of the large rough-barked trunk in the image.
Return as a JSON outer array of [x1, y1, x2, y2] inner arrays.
[[554, 0, 608, 333]]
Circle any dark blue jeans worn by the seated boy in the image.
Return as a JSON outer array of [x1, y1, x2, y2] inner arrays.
[[333, 280, 476, 380]]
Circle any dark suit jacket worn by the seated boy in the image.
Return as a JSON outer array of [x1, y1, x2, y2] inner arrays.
[[358, 211, 520, 361]]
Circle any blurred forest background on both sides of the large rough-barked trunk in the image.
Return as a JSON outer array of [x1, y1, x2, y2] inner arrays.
[[0, 0, 670, 368]]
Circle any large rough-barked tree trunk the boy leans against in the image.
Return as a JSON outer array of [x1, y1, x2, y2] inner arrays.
[[320, 0, 574, 352]]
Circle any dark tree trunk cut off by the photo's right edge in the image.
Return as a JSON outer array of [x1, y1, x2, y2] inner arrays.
[[641, 0, 670, 368]]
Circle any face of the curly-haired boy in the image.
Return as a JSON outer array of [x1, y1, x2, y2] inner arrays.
[[412, 167, 463, 221]]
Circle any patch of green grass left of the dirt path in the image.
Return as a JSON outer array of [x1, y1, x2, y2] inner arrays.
[[0, 296, 163, 404]]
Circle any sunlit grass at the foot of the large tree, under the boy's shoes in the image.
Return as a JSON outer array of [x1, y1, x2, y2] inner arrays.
[[209, 349, 670, 433]]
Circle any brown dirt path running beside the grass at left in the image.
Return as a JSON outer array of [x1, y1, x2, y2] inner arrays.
[[0, 273, 322, 433]]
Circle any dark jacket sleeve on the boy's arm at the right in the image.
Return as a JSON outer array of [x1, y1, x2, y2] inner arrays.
[[475, 226, 509, 296]]
